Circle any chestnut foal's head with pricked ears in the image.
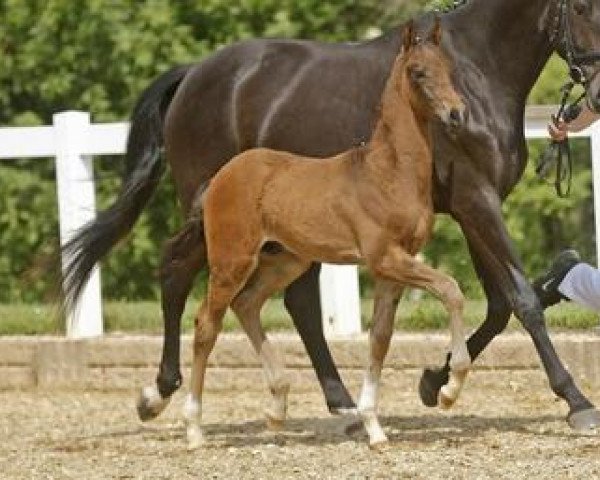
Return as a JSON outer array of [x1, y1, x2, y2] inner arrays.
[[396, 19, 465, 128]]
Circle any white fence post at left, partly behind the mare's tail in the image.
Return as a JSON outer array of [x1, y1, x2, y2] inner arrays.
[[53, 111, 102, 338]]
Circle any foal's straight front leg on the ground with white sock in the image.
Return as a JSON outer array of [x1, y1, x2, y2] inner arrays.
[[357, 280, 402, 450]]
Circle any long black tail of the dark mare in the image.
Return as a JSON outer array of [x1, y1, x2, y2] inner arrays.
[[61, 65, 191, 308]]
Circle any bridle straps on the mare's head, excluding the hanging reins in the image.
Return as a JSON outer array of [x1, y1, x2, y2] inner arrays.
[[551, 0, 600, 90]]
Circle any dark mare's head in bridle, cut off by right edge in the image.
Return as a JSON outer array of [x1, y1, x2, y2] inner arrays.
[[556, 0, 600, 112]]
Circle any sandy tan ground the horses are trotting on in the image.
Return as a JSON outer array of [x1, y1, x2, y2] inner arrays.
[[0, 370, 600, 479]]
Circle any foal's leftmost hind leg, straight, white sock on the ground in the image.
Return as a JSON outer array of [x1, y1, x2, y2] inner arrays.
[[183, 252, 256, 449]]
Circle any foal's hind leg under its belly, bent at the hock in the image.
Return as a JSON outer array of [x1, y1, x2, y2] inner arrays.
[[231, 252, 310, 430]]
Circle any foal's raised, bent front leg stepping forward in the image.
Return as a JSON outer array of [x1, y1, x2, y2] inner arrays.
[[372, 247, 471, 408]]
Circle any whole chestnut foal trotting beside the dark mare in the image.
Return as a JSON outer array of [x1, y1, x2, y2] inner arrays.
[[184, 22, 471, 448]]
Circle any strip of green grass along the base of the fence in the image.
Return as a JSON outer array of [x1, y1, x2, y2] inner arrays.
[[0, 299, 599, 335]]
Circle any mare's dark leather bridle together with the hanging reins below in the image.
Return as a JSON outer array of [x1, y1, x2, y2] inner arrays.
[[535, 0, 600, 198]]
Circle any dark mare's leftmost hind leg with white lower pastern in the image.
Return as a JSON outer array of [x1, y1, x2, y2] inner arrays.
[[137, 218, 206, 421]]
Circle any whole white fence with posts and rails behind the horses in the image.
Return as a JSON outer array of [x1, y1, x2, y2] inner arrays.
[[0, 107, 600, 338]]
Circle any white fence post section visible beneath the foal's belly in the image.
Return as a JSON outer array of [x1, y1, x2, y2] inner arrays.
[[319, 264, 361, 337]]
